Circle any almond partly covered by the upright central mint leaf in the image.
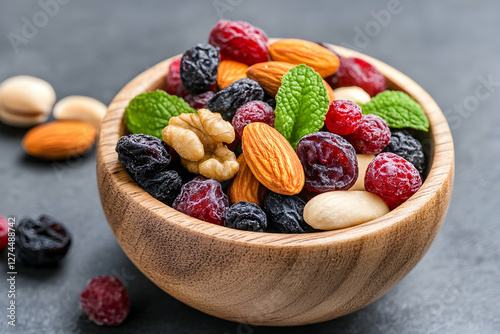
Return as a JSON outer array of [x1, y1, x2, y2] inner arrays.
[[247, 61, 335, 101]]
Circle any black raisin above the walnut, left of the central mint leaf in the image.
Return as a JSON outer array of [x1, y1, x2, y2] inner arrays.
[[206, 78, 264, 122]]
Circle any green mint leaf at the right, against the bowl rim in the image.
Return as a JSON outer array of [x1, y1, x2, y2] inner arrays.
[[361, 90, 429, 131]]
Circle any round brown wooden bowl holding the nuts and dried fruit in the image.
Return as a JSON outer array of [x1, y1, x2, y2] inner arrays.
[[97, 42, 454, 326]]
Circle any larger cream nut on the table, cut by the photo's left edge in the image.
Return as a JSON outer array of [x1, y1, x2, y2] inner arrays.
[[0, 75, 56, 127]]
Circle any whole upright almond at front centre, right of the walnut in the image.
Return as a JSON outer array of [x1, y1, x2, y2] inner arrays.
[[241, 122, 305, 195]]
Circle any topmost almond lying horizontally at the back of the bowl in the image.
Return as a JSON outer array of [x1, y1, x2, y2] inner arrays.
[[269, 39, 340, 78]]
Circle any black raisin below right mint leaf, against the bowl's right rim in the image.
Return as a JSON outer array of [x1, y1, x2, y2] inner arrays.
[[384, 130, 425, 174]]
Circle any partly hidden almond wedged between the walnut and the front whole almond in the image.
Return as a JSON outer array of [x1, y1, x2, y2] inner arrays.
[[228, 153, 268, 206]]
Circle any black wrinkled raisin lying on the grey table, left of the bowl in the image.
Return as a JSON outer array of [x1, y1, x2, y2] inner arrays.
[[15, 215, 71, 267]]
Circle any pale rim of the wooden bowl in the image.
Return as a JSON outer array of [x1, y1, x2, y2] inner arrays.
[[98, 39, 454, 247]]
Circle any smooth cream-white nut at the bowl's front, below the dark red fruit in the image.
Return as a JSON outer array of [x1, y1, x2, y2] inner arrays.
[[304, 191, 389, 230]]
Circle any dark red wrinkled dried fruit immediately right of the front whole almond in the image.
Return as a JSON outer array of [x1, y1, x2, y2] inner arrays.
[[297, 132, 358, 193]]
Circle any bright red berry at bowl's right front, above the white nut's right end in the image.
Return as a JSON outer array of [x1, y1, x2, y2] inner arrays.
[[365, 153, 422, 210]]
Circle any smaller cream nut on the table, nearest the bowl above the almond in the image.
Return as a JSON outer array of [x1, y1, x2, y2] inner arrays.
[[54, 95, 108, 128]]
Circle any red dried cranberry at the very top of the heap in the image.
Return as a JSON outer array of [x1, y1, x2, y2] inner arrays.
[[208, 20, 269, 65]]
